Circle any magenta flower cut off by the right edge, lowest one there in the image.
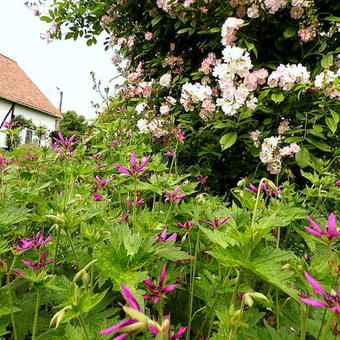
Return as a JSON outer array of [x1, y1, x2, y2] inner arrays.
[[300, 271, 340, 313]]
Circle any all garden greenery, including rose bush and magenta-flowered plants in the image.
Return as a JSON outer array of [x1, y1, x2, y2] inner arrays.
[[0, 0, 340, 340]]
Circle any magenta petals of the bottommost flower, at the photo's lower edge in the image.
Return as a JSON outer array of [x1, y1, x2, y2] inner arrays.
[[100, 285, 142, 340]]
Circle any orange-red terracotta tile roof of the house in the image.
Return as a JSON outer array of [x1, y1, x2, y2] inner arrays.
[[0, 54, 62, 118]]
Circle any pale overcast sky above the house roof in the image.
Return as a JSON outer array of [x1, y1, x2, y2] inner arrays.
[[0, 0, 117, 118]]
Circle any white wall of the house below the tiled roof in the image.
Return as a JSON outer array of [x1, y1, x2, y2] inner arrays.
[[0, 98, 58, 148]]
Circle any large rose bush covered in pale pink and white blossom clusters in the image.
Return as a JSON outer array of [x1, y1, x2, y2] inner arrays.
[[30, 0, 339, 191]]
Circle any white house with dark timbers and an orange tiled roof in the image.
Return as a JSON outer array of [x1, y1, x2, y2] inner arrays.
[[0, 54, 62, 148]]
